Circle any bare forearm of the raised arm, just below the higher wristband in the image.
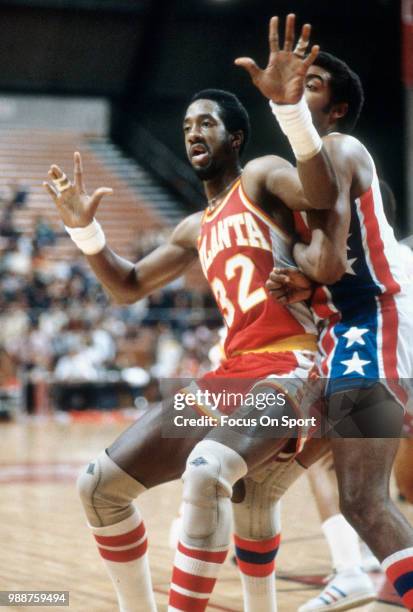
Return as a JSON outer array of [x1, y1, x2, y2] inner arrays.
[[297, 147, 338, 209]]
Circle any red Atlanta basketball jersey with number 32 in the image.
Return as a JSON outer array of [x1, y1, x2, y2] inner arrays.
[[198, 180, 316, 357]]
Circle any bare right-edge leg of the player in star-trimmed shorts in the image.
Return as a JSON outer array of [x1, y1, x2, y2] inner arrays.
[[331, 385, 413, 609]]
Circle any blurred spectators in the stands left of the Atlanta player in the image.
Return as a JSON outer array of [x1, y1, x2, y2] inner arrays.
[[0, 187, 219, 414]]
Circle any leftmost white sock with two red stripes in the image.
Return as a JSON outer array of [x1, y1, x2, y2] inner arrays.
[[92, 510, 156, 612]]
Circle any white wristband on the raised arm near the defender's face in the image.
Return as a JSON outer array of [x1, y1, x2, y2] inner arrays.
[[270, 97, 323, 161]]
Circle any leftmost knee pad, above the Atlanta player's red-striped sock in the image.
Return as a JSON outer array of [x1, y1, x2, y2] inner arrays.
[[77, 451, 145, 527]]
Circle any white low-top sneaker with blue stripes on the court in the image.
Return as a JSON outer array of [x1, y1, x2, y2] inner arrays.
[[298, 568, 376, 612]]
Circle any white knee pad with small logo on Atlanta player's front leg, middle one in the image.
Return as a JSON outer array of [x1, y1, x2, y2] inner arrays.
[[182, 440, 247, 546]]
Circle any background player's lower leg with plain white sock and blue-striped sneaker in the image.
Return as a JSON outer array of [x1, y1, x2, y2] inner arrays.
[[299, 452, 374, 612]]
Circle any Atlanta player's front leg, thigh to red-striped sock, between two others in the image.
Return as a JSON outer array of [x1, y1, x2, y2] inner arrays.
[[170, 353, 313, 611]]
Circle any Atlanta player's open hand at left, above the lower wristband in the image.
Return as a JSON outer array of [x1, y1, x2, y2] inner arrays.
[[43, 152, 113, 227]]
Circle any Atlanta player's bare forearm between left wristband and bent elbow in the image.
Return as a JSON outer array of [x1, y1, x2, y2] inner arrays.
[[87, 246, 142, 304]]
